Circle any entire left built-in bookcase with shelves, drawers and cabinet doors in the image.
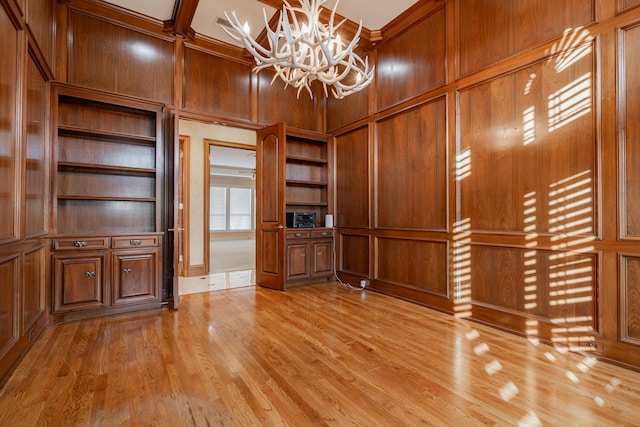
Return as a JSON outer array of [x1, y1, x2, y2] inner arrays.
[[52, 85, 164, 321]]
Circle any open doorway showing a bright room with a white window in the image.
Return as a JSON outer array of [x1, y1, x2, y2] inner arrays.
[[205, 139, 256, 290]]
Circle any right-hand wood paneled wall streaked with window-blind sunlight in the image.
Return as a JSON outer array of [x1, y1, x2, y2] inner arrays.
[[327, 0, 640, 368]]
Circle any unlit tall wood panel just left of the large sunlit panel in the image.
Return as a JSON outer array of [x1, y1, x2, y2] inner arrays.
[[376, 98, 447, 230]]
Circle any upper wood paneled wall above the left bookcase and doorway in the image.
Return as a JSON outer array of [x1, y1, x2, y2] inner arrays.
[[56, 0, 324, 131]]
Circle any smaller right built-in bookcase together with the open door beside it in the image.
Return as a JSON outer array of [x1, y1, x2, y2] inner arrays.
[[256, 123, 334, 290]]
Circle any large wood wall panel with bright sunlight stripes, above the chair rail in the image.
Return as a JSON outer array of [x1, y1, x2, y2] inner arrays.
[[457, 43, 598, 235]]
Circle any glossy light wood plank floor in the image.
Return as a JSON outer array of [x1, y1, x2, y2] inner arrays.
[[0, 284, 640, 426]]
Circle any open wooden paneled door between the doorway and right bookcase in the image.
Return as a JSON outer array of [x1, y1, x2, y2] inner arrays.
[[256, 123, 286, 290]]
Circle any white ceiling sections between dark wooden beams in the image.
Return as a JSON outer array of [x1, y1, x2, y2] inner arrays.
[[100, 0, 417, 45]]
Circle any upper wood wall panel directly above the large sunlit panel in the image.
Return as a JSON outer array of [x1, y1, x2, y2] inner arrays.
[[455, 0, 596, 76]]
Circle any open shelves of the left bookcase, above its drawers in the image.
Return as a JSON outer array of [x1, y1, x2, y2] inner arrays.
[[54, 89, 161, 234]]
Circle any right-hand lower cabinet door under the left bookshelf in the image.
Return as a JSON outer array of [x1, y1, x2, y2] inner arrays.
[[113, 251, 158, 305]]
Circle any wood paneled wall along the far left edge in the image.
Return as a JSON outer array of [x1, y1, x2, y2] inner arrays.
[[0, 0, 55, 384]]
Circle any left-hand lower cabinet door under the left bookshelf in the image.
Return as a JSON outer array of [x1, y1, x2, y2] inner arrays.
[[53, 253, 106, 313]]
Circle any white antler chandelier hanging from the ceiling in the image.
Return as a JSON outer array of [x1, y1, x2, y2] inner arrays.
[[222, 0, 375, 98]]
